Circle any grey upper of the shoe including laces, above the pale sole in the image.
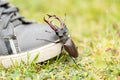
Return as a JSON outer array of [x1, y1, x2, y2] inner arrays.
[[0, 1, 58, 55]]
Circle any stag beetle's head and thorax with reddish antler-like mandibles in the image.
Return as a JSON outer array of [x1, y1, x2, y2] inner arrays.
[[44, 14, 68, 43]]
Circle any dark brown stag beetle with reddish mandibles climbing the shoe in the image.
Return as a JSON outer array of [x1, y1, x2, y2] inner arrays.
[[44, 14, 78, 58]]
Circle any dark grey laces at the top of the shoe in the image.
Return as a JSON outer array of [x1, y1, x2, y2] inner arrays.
[[0, 1, 31, 29]]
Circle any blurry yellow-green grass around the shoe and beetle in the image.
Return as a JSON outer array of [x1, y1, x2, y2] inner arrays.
[[0, 0, 120, 80]]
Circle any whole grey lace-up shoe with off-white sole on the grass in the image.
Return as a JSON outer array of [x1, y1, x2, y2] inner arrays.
[[0, 1, 78, 68]]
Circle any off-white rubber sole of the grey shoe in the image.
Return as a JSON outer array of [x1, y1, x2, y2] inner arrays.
[[0, 43, 62, 68]]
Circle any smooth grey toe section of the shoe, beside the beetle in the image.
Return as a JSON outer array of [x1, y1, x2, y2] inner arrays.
[[15, 23, 58, 51]]
